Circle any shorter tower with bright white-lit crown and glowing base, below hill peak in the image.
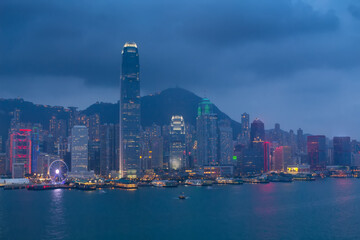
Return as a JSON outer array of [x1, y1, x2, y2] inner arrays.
[[170, 116, 186, 169]]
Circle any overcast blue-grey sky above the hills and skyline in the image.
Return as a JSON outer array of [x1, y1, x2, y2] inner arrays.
[[0, 0, 360, 139]]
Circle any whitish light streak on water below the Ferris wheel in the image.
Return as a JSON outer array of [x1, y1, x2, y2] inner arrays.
[[45, 189, 67, 239]]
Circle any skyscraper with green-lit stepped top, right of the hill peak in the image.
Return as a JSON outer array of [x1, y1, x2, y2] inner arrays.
[[196, 98, 219, 166]]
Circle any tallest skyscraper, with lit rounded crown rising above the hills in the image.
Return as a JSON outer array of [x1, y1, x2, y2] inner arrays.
[[119, 42, 140, 177]]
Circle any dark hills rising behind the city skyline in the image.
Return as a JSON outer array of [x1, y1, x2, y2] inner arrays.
[[0, 88, 240, 147]]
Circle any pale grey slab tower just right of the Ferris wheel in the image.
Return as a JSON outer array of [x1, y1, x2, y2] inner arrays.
[[71, 125, 89, 172]]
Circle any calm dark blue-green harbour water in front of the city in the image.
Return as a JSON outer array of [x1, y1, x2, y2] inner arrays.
[[0, 178, 360, 240]]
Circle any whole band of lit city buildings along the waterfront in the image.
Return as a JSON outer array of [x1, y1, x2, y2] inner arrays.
[[0, 42, 360, 186]]
